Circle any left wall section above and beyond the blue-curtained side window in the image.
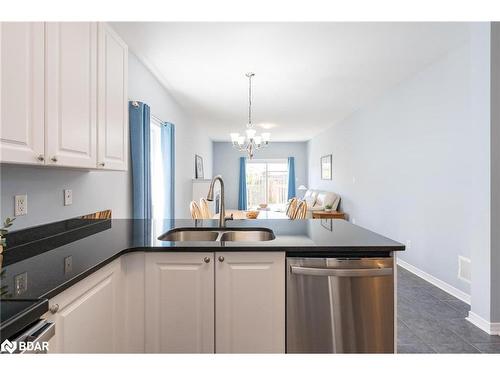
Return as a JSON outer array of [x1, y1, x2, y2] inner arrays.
[[128, 53, 212, 218]]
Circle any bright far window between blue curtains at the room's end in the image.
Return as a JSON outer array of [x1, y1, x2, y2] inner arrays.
[[246, 159, 288, 209]]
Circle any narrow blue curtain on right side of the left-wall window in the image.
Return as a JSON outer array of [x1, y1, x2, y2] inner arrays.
[[161, 122, 175, 219]]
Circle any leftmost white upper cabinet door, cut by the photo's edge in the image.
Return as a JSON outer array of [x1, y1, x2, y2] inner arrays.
[[0, 22, 44, 164]]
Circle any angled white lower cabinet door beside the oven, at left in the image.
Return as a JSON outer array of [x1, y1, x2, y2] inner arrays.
[[48, 259, 123, 353]]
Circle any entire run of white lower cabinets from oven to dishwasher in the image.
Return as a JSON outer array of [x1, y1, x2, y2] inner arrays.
[[45, 251, 285, 353]]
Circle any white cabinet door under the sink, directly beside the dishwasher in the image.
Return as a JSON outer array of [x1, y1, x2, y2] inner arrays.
[[215, 252, 285, 353]]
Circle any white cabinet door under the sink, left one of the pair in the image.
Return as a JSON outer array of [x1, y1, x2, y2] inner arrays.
[[146, 253, 214, 353]]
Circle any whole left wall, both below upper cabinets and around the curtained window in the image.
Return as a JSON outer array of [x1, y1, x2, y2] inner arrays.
[[0, 54, 212, 230]]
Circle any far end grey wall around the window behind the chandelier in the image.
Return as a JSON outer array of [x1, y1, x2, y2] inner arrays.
[[213, 142, 307, 209]]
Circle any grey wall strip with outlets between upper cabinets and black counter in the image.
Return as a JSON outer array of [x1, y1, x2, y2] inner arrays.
[[0, 165, 131, 230]]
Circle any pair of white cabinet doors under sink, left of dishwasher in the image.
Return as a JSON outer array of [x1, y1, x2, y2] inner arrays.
[[145, 252, 285, 353]]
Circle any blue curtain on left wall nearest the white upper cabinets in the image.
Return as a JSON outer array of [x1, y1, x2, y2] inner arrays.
[[128, 102, 152, 219]]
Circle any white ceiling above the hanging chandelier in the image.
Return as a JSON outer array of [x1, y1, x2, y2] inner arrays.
[[112, 22, 469, 141]]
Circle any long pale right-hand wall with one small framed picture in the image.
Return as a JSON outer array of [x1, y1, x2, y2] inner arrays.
[[308, 27, 489, 293]]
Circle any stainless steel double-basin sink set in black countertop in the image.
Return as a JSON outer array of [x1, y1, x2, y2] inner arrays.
[[158, 228, 276, 242]]
